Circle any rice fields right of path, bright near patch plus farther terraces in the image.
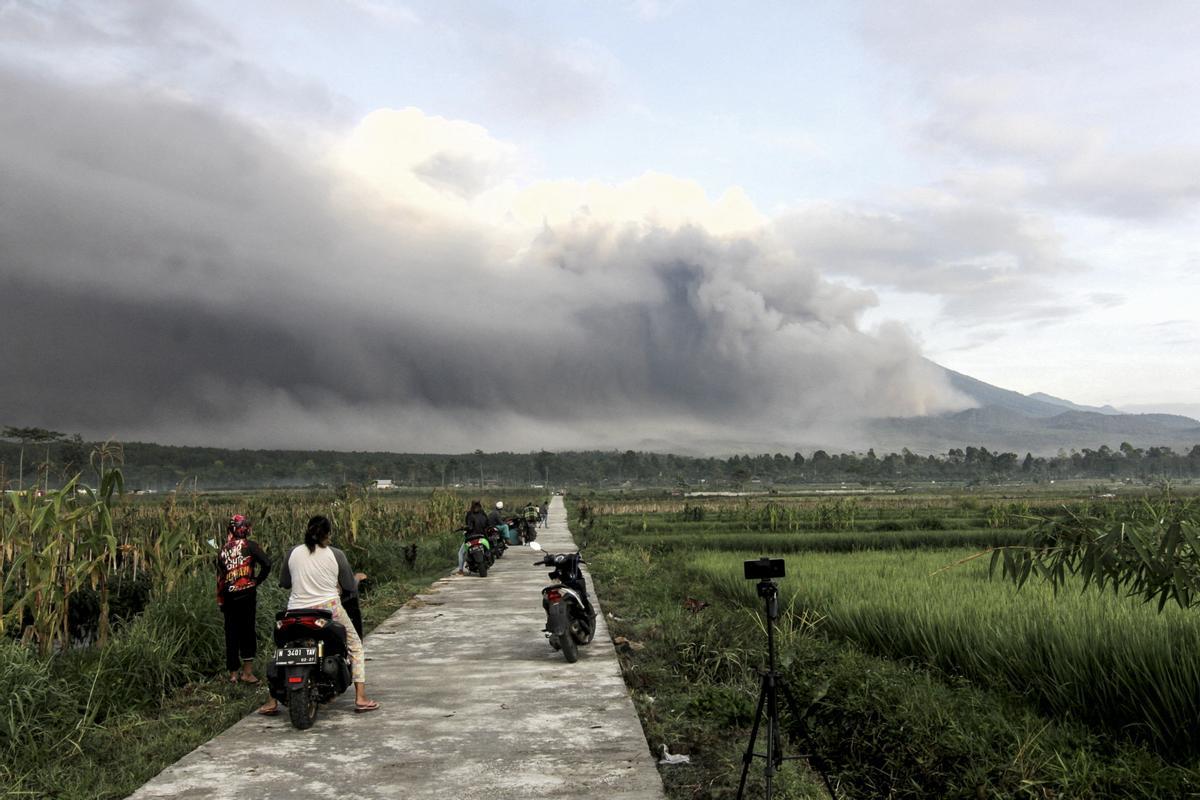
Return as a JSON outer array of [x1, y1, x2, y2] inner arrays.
[[590, 484, 1200, 760]]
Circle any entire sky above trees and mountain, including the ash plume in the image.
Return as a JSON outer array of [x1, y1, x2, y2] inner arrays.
[[0, 0, 1200, 451]]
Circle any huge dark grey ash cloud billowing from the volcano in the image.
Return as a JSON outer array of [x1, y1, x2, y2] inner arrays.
[[0, 72, 966, 451]]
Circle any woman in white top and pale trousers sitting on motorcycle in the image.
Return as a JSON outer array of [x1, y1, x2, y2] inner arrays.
[[258, 516, 379, 716]]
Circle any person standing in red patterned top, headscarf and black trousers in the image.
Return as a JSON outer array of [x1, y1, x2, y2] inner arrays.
[[216, 513, 271, 684]]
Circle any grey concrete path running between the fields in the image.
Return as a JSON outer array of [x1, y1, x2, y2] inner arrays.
[[131, 497, 662, 800]]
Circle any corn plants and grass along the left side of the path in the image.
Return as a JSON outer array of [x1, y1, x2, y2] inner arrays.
[[0, 474, 464, 799]]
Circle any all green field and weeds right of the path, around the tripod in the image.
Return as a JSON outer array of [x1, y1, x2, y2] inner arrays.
[[585, 493, 1200, 798]]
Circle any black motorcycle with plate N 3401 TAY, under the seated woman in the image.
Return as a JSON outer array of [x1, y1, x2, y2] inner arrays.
[[266, 608, 352, 730]]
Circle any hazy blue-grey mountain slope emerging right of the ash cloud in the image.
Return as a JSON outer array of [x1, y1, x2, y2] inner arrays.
[[868, 369, 1200, 455]]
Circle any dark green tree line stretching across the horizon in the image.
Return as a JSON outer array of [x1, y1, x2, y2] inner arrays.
[[7, 428, 1200, 492]]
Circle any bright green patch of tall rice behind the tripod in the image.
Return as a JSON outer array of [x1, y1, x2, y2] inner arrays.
[[688, 548, 1200, 753]]
